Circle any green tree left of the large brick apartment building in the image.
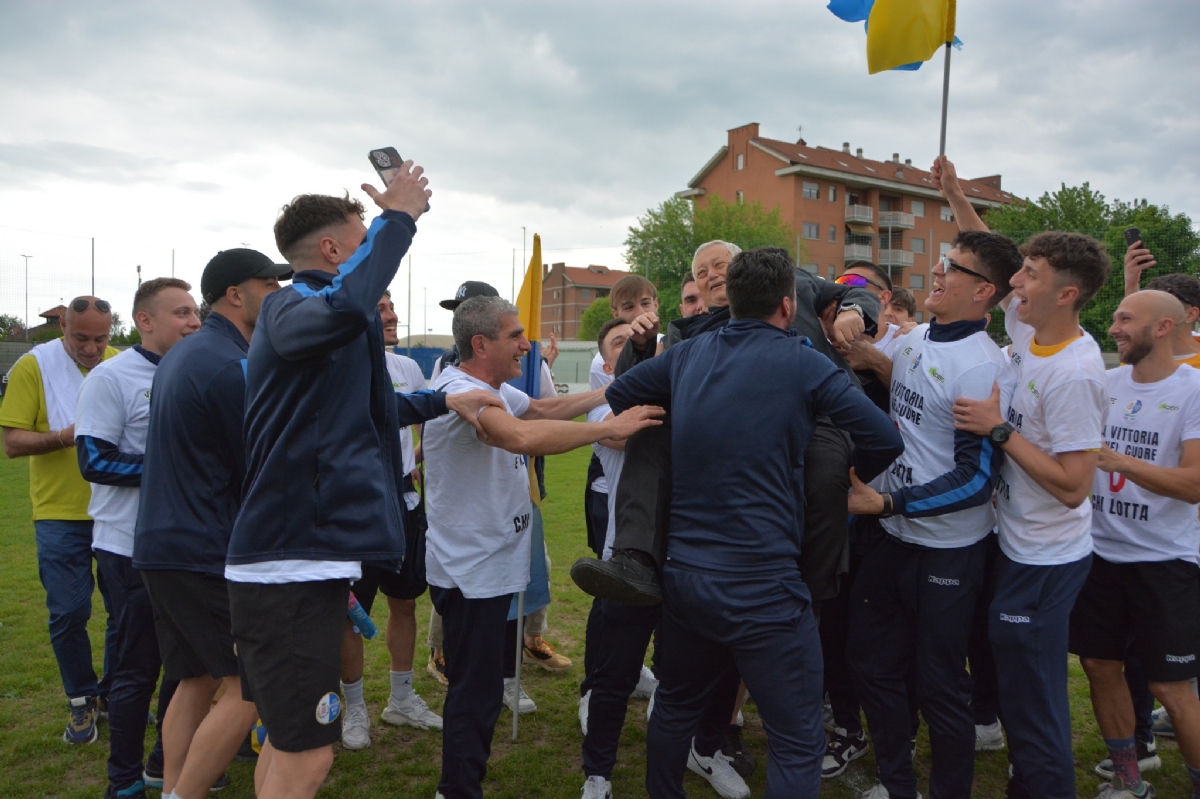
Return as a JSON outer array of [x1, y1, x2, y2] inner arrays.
[[624, 194, 798, 323]]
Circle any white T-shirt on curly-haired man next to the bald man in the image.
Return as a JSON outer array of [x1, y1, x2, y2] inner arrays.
[[996, 298, 1109, 566]]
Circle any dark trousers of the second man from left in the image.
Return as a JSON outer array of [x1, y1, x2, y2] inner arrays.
[[96, 549, 174, 788]]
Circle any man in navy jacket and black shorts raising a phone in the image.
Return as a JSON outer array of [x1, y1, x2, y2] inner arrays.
[[226, 163, 494, 798]]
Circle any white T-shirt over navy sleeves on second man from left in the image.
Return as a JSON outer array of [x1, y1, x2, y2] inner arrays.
[[76, 348, 158, 558]]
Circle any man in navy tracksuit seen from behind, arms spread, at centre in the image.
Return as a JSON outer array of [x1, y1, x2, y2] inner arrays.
[[607, 248, 904, 799]]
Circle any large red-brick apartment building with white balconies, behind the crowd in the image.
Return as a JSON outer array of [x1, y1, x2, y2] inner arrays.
[[677, 122, 1013, 320]]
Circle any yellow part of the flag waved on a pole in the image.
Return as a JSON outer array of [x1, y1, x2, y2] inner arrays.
[[866, 0, 955, 74]]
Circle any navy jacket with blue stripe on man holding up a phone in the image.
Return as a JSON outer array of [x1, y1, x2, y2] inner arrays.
[[227, 211, 446, 565]]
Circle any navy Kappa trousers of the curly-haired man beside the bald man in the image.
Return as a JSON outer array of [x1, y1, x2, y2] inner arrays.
[[988, 552, 1092, 799]]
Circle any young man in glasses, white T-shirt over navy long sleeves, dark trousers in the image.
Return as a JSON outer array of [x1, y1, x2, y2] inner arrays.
[[847, 230, 1021, 799]]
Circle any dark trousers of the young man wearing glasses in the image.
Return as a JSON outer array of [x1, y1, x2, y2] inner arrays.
[[847, 527, 988, 799]]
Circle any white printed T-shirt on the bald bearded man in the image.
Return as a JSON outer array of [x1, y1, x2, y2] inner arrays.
[[1092, 366, 1200, 563]]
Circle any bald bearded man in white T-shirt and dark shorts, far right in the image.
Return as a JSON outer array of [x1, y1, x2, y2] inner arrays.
[[1069, 290, 1200, 799]]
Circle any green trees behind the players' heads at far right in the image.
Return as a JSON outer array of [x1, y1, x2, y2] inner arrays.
[[986, 184, 1200, 350]]
